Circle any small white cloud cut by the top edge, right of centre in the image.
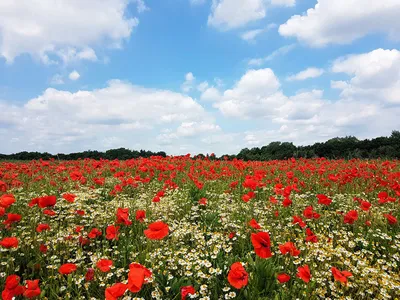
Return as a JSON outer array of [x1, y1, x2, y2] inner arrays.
[[208, 0, 295, 30]]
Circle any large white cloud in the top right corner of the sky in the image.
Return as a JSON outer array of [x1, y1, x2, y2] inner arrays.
[[279, 0, 400, 47]]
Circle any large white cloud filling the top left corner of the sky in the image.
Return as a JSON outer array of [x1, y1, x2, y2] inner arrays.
[[0, 0, 141, 63]]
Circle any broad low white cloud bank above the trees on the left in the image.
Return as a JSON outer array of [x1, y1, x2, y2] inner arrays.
[[0, 80, 214, 153]]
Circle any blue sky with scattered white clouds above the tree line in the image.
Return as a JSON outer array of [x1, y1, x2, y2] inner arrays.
[[0, 0, 400, 155]]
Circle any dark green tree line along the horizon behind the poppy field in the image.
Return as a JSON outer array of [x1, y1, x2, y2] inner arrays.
[[0, 130, 400, 160]]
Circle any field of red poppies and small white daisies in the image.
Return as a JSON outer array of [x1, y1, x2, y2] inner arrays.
[[0, 155, 400, 300]]
